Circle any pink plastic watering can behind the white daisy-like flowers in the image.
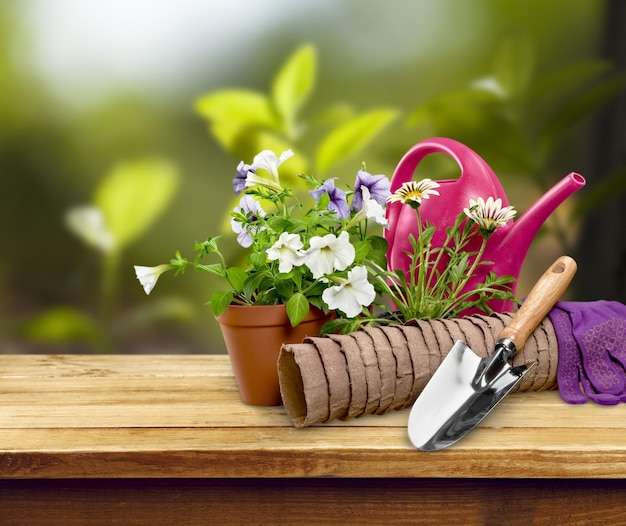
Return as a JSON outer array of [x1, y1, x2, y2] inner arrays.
[[385, 137, 585, 314]]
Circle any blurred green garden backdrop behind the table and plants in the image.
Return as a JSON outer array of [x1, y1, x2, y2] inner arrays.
[[0, 0, 626, 353]]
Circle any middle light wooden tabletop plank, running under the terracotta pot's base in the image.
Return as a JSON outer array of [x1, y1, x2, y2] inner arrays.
[[0, 375, 626, 429]]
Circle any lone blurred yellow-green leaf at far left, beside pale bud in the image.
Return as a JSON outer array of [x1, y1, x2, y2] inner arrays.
[[94, 159, 179, 247]]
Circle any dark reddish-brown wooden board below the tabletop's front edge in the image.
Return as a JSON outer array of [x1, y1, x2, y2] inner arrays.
[[0, 479, 626, 526]]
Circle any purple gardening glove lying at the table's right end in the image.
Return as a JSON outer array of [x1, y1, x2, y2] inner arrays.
[[549, 301, 626, 405]]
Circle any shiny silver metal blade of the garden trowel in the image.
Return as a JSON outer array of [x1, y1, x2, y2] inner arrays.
[[408, 341, 535, 451]]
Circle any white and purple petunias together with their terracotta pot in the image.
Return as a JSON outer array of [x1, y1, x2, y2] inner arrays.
[[135, 150, 390, 405]]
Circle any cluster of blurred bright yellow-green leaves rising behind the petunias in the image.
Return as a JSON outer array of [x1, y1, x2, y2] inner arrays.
[[195, 44, 399, 177]]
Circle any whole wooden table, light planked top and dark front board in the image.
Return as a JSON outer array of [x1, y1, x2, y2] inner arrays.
[[0, 355, 626, 526]]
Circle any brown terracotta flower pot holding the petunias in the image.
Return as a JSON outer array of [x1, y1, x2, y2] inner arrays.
[[217, 305, 330, 406]]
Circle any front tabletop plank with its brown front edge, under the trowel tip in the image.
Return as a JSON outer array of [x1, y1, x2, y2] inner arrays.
[[0, 427, 626, 478]]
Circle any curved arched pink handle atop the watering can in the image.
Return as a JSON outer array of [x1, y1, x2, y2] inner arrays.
[[391, 137, 504, 195]]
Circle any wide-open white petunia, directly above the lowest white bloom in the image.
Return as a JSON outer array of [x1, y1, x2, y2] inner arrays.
[[304, 230, 355, 279]]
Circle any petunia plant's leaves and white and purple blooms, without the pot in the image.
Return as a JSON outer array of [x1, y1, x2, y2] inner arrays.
[[153, 152, 390, 327]]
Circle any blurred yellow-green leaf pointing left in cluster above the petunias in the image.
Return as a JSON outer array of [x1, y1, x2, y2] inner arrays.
[[195, 89, 278, 129]]
